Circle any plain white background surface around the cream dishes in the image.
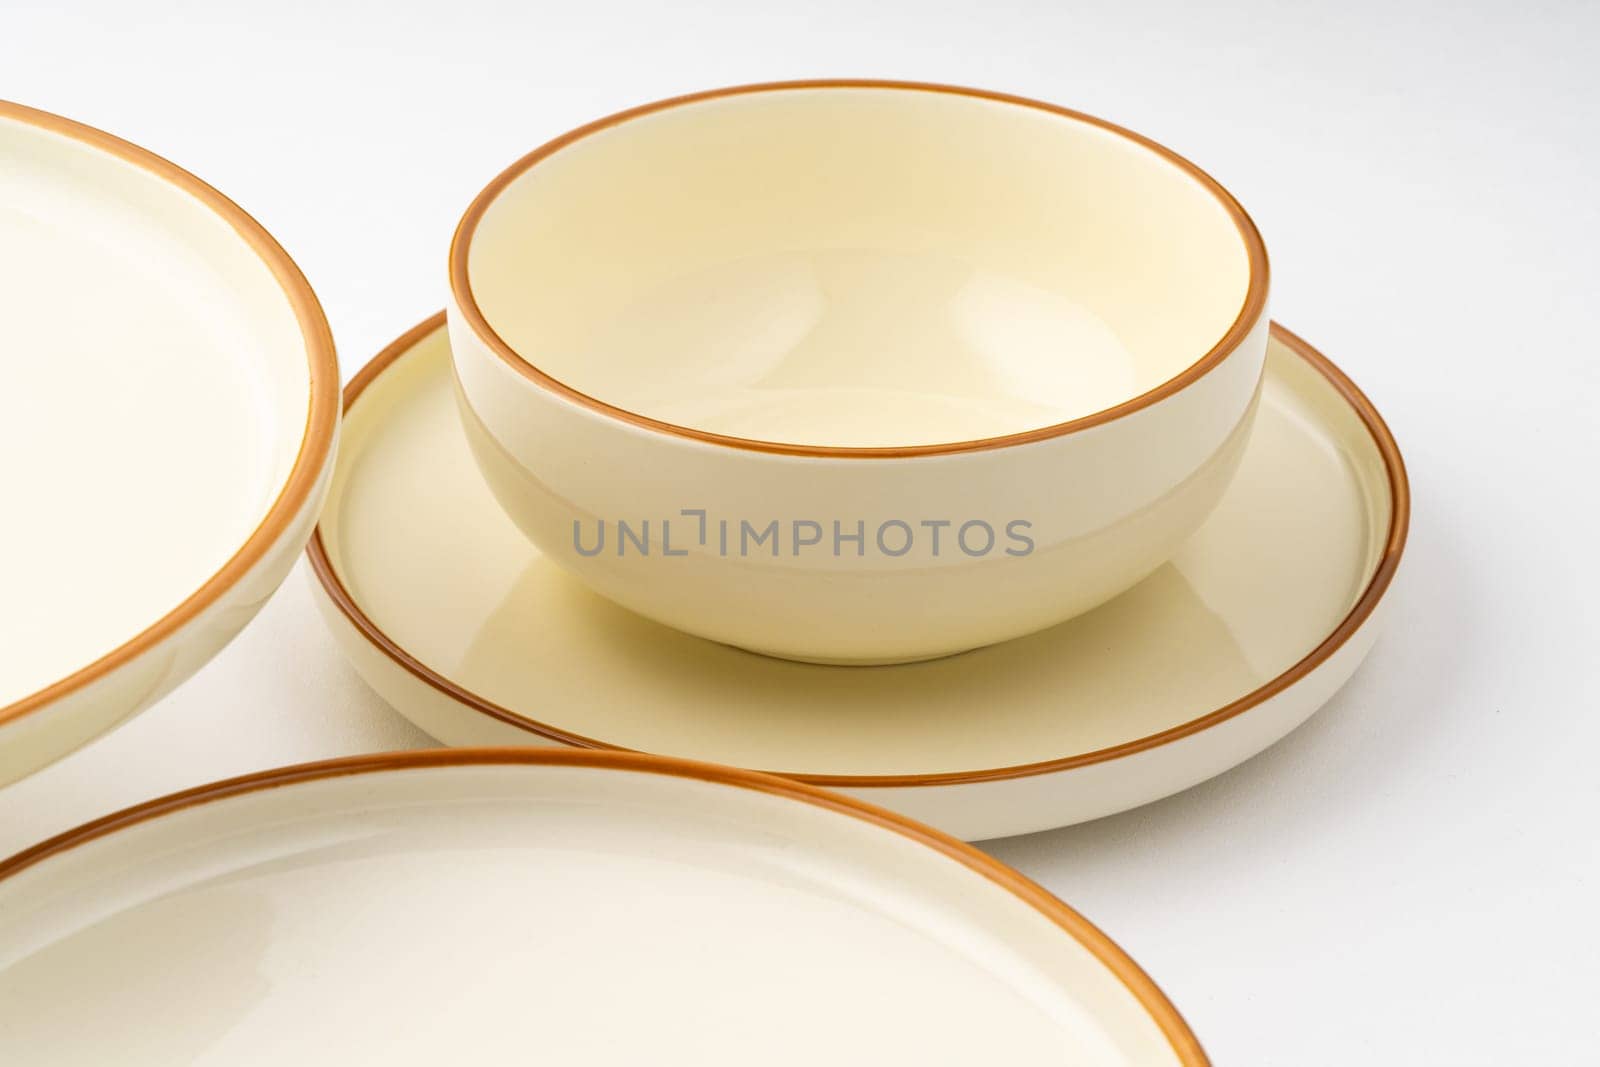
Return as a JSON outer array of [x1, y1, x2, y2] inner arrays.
[[0, 0, 1600, 1067]]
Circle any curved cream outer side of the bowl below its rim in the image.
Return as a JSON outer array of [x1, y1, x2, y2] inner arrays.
[[450, 300, 1269, 664]]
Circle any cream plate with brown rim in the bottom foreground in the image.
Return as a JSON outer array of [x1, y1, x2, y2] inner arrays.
[[0, 749, 1205, 1067]]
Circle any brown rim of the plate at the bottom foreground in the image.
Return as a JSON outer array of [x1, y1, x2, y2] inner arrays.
[[0, 747, 1211, 1067]]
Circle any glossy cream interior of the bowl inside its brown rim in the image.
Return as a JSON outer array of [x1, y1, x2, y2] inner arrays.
[[467, 86, 1251, 448]]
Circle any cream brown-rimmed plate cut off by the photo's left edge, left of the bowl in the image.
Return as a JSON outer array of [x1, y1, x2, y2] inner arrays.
[[0, 102, 339, 784]]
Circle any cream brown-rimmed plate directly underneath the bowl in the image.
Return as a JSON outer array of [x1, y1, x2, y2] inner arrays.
[[310, 317, 1408, 838]]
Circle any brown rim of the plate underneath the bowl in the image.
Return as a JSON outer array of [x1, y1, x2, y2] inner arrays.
[[306, 312, 1411, 789]]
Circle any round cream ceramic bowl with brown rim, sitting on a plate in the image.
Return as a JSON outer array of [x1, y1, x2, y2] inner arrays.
[[450, 82, 1267, 662]]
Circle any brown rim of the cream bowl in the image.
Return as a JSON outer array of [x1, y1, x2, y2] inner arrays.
[[450, 78, 1270, 459]]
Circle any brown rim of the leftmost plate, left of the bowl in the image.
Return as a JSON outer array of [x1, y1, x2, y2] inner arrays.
[[0, 99, 339, 726]]
